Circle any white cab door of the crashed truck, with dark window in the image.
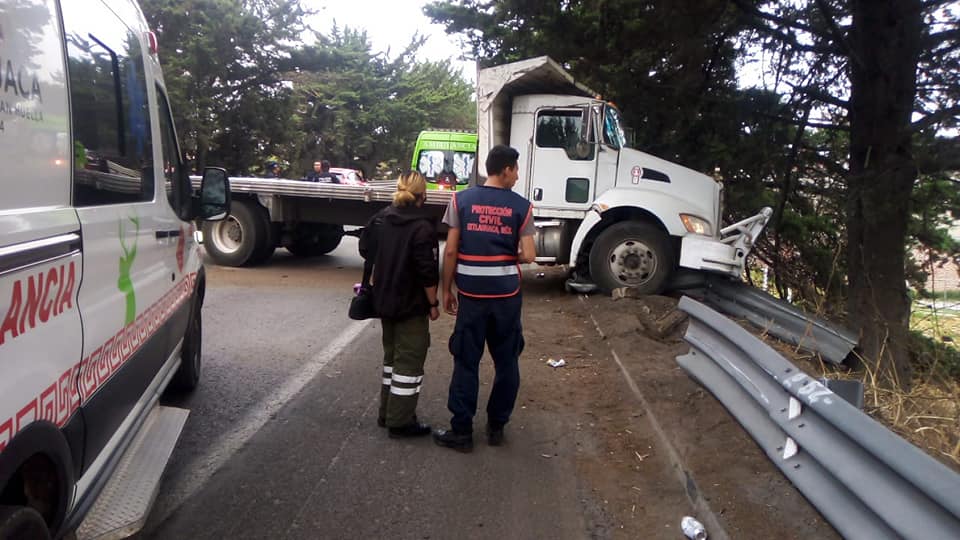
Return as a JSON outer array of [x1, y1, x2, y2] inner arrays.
[[527, 107, 597, 210]]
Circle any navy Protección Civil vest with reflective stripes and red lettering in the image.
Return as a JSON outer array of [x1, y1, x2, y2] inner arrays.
[[453, 186, 533, 298]]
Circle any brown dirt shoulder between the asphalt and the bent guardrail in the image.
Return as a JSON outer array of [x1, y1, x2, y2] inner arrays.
[[521, 271, 838, 539]]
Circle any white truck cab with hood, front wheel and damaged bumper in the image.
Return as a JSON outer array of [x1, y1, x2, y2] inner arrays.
[[477, 57, 771, 293]]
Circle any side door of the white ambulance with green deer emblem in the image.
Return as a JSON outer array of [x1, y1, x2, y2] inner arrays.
[[61, 2, 176, 471]]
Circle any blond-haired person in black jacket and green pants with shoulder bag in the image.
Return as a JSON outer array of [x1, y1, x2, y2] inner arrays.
[[360, 172, 440, 438]]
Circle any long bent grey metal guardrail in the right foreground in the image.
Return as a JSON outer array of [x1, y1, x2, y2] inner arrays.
[[677, 297, 960, 539]]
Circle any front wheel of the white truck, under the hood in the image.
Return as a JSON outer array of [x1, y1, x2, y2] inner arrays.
[[590, 221, 673, 294]]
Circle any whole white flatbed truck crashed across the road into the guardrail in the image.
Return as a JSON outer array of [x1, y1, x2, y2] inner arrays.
[[204, 56, 772, 293]]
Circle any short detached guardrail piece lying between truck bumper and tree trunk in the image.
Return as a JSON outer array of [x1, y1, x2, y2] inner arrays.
[[704, 276, 858, 364]]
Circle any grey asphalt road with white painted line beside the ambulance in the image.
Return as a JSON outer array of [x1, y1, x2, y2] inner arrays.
[[140, 238, 589, 539]]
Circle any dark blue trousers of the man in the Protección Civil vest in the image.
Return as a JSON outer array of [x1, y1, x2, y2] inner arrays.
[[447, 294, 524, 433]]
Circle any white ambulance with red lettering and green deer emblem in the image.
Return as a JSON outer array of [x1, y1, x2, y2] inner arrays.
[[0, 0, 230, 539]]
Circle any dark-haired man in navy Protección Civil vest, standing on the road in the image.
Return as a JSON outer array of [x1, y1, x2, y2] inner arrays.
[[433, 145, 536, 452]]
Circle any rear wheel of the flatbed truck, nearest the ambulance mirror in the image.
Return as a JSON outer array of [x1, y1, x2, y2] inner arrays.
[[203, 200, 268, 266]]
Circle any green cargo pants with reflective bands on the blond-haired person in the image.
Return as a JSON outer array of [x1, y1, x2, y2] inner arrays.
[[380, 315, 430, 427]]
